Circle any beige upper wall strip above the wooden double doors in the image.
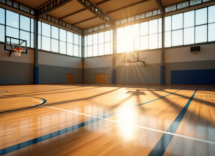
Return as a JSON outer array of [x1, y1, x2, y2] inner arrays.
[[84, 55, 113, 68]]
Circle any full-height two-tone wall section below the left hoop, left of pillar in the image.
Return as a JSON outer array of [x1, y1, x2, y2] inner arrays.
[[0, 43, 34, 85]]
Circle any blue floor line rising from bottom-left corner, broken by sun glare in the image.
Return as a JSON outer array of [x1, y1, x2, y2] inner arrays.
[[0, 89, 183, 155]]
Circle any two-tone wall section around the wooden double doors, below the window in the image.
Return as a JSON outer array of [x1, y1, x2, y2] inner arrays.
[[84, 55, 113, 83]]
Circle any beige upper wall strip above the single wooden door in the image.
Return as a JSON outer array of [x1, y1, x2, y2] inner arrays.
[[38, 51, 82, 68]]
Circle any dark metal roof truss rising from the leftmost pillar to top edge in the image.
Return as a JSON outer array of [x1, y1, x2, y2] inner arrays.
[[36, 0, 72, 17]]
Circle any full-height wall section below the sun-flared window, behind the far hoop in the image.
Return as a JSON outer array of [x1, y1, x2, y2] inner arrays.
[[116, 49, 161, 84]]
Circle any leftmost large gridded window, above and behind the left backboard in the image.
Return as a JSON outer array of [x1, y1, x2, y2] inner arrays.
[[0, 8, 34, 48]]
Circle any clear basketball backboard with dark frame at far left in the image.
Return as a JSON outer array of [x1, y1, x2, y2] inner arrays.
[[4, 36, 28, 56]]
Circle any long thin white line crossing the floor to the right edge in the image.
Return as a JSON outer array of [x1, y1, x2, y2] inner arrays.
[[40, 106, 215, 145]]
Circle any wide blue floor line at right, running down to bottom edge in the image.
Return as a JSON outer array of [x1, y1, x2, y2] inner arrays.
[[148, 87, 198, 156]]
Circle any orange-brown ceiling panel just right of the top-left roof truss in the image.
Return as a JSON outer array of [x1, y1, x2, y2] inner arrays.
[[49, 0, 84, 18]]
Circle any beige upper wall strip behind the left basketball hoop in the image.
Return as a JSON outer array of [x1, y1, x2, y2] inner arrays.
[[0, 44, 34, 64]]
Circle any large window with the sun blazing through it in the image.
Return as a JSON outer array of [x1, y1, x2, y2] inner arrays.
[[117, 19, 162, 53]]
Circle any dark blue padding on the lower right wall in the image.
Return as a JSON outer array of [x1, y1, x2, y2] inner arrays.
[[171, 69, 215, 85]]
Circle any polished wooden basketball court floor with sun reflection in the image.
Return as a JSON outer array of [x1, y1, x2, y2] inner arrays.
[[0, 85, 215, 156]]
